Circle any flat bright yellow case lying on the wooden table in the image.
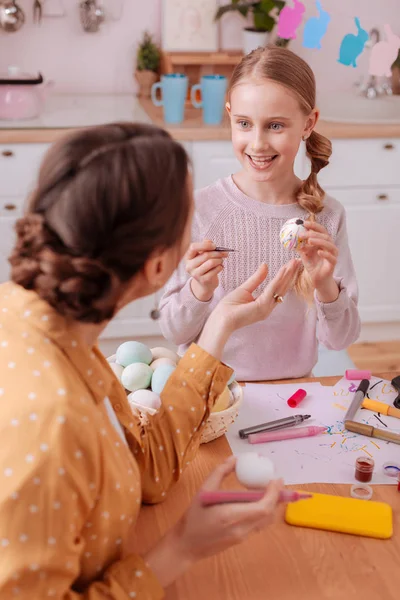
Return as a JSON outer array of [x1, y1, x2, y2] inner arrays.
[[285, 494, 393, 540]]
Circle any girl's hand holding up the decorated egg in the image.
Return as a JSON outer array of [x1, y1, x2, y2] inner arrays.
[[299, 221, 339, 302]]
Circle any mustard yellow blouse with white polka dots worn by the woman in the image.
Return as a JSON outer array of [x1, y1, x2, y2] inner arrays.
[[0, 283, 231, 600]]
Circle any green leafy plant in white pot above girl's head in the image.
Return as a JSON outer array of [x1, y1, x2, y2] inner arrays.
[[215, 0, 288, 54]]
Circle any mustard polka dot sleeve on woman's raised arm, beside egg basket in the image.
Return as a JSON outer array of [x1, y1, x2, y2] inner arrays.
[[119, 344, 232, 503]]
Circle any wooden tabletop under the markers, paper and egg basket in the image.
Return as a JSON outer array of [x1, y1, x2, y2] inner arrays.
[[137, 373, 400, 600]]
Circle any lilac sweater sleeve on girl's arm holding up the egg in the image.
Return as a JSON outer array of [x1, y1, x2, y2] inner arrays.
[[314, 207, 361, 350]]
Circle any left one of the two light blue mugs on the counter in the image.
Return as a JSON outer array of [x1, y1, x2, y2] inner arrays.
[[151, 73, 188, 125]]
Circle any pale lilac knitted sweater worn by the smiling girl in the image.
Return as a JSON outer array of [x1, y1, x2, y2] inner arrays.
[[160, 177, 360, 381]]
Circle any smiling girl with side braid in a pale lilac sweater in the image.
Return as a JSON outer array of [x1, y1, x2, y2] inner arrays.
[[160, 46, 360, 381]]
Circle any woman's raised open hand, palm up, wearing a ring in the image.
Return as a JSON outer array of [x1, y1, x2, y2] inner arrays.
[[198, 259, 301, 359]]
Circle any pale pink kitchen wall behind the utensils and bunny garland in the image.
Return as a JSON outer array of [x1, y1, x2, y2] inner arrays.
[[0, 0, 400, 93]]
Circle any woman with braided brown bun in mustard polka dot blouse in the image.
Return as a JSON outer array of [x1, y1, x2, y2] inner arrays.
[[0, 123, 297, 600]]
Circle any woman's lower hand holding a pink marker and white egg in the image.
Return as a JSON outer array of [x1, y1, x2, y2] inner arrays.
[[146, 456, 283, 586]]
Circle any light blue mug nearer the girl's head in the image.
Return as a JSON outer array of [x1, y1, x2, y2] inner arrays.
[[190, 75, 227, 125]]
